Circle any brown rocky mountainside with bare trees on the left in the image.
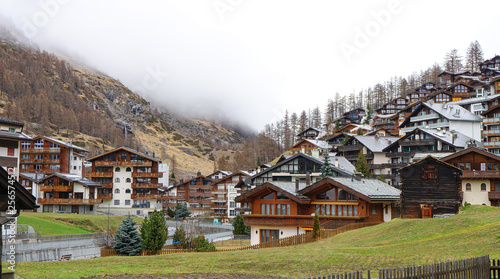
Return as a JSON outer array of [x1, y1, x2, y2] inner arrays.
[[0, 28, 244, 178]]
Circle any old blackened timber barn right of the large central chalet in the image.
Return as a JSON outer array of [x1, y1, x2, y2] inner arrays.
[[399, 156, 462, 218]]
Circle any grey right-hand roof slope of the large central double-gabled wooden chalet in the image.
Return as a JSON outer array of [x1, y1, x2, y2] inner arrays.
[[330, 177, 401, 200]]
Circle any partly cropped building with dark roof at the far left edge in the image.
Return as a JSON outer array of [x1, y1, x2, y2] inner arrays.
[[0, 117, 32, 178]]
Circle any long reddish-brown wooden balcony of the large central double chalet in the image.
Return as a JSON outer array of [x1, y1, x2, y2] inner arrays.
[[244, 214, 367, 227]]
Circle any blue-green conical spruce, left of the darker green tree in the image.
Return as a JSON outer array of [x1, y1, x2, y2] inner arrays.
[[113, 216, 142, 256]]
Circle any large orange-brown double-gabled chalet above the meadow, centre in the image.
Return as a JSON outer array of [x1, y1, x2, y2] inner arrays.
[[236, 176, 400, 245]]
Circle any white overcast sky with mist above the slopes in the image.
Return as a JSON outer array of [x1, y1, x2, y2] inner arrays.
[[0, 0, 500, 130]]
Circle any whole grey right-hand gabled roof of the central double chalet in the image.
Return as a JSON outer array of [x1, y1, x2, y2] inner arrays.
[[299, 177, 401, 202]]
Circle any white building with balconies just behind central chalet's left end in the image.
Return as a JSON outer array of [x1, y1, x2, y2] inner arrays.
[[211, 171, 250, 218]]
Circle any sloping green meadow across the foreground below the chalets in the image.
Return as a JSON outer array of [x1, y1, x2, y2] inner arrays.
[[9, 206, 500, 278]]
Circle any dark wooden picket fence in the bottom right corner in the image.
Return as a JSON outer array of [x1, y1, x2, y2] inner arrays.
[[290, 256, 492, 279]]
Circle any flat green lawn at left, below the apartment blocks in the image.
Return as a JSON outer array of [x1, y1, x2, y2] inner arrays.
[[18, 212, 142, 236]]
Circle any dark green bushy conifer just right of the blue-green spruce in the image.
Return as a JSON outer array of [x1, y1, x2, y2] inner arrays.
[[140, 209, 168, 254]]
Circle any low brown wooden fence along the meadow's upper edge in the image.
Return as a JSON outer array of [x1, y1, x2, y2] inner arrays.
[[101, 223, 380, 257]]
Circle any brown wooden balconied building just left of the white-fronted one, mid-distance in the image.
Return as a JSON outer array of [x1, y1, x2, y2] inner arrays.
[[174, 175, 214, 216]]
